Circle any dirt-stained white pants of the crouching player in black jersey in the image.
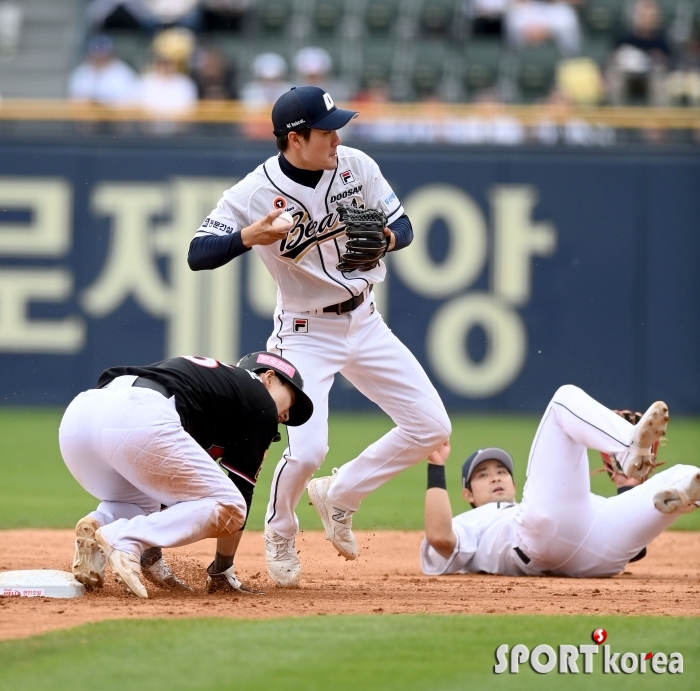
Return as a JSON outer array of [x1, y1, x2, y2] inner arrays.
[[59, 376, 247, 555]]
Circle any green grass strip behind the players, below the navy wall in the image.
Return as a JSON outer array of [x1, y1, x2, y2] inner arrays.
[[0, 408, 700, 530]]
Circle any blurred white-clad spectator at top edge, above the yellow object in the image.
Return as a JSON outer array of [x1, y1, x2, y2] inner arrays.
[[506, 0, 581, 55]]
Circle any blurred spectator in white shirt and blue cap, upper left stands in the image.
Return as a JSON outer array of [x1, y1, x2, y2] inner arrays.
[[68, 35, 137, 106]]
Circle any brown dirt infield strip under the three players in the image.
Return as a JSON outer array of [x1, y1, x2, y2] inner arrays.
[[0, 530, 700, 639]]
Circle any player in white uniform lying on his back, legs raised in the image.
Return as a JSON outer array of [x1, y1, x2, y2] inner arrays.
[[421, 386, 700, 577]]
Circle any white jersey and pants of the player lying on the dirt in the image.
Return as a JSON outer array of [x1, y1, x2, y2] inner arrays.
[[420, 386, 697, 577]]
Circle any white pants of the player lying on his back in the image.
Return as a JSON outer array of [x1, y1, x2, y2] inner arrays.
[[515, 386, 698, 577]]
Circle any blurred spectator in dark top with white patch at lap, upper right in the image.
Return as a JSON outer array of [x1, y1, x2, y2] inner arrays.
[[607, 0, 671, 106]]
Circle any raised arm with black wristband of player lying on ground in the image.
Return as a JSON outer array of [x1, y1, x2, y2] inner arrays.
[[425, 440, 457, 557]]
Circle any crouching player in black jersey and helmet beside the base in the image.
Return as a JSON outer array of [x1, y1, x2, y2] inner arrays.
[[59, 352, 313, 598]]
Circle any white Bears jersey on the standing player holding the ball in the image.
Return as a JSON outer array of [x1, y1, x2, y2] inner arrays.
[[195, 146, 404, 312]]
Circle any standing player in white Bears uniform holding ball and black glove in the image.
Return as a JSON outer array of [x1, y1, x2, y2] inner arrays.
[[189, 86, 451, 587]]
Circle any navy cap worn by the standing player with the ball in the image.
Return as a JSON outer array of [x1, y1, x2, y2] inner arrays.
[[272, 86, 359, 137]]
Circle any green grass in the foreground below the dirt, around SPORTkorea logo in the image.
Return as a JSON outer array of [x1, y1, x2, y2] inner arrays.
[[0, 615, 700, 691]]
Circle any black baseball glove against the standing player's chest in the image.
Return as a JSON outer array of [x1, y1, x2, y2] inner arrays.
[[336, 204, 390, 271]]
